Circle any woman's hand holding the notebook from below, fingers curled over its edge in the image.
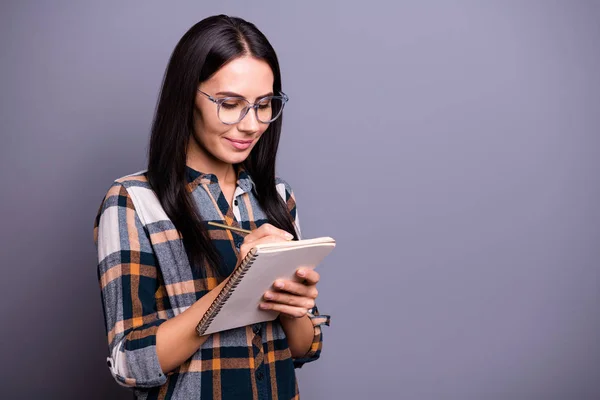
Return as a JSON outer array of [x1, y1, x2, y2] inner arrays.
[[260, 268, 319, 318]]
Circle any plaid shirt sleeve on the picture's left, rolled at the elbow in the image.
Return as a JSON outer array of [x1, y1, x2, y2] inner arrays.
[[94, 182, 167, 388]]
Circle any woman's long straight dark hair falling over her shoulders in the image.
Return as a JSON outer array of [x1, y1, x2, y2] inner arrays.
[[147, 15, 297, 275]]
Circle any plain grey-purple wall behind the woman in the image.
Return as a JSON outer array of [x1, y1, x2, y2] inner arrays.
[[0, 0, 600, 400]]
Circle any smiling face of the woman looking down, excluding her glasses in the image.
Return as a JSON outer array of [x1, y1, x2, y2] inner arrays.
[[188, 57, 274, 169]]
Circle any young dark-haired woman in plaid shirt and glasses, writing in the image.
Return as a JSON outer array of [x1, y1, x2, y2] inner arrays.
[[94, 15, 329, 400]]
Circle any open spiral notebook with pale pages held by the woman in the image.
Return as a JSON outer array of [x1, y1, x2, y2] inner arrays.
[[196, 237, 335, 336]]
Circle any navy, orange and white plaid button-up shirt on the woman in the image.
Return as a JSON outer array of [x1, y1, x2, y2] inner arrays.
[[94, 168, 329, 400]]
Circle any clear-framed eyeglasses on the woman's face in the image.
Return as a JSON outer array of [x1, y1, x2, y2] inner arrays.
[[198, 89, 289, 125]]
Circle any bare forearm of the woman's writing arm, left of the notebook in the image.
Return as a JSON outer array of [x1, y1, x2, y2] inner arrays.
[[156, 279, 227, 374]]
